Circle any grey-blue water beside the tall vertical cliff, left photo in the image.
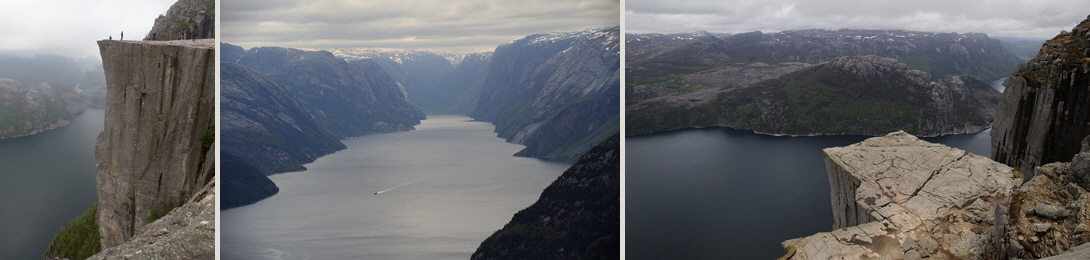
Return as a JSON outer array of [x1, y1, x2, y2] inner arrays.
[[0, 109, 105, 259]]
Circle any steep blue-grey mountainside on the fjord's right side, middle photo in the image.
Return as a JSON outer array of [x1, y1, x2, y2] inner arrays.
[[469, 27, 620, 161]]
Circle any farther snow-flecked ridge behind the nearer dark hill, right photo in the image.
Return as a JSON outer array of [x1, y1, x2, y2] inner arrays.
[[625, 29, 1022, 79]]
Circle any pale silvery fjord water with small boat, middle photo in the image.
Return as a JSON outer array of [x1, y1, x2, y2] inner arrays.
[[220, 115, 568, 259]]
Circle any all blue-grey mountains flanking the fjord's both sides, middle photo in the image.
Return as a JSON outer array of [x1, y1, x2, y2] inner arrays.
[[220, 27, 620, 206]]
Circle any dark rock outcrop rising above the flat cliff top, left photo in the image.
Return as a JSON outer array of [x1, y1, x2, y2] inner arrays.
[[144, 0, 216, 40]]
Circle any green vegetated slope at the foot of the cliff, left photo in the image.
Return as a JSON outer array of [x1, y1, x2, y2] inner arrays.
[[45, 201, 102, 259]]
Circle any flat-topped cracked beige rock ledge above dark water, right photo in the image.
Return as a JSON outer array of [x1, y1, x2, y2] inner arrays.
[[783, 132, 1021, 259]]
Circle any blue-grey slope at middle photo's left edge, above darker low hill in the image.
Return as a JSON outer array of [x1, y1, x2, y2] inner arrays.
[[220, 63, 344, 174]]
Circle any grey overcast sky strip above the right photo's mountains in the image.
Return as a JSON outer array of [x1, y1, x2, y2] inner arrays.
[[625, 0, 1090, 38]]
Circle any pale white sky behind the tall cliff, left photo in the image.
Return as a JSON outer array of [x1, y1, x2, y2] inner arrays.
[[0, 0, 177, 58]]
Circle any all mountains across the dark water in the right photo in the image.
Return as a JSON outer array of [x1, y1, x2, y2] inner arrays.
[[626, 29, 1022, 136]]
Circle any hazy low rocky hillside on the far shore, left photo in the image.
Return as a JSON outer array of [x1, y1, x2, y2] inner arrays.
[[0, 77, 90, 138]]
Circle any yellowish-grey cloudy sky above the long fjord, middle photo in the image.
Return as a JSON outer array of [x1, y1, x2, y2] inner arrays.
[[220, 0, 620, 52]]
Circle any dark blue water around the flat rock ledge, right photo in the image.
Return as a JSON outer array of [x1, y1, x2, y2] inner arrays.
[[625, 127, 991, 260]]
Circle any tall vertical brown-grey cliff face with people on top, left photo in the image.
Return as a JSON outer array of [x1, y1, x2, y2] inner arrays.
[[95, 39, 216, 248]]
